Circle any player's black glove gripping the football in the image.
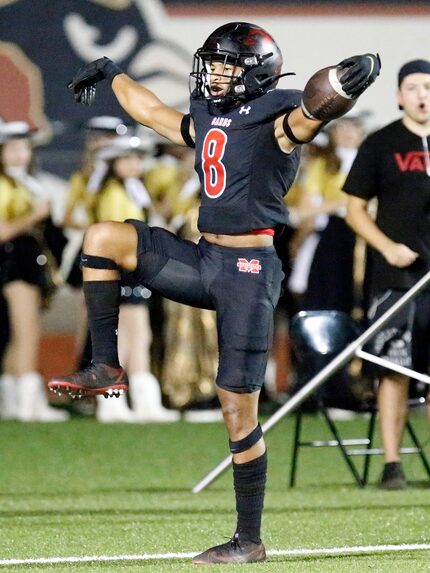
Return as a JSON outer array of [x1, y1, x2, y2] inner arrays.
[[337, 54, 381, 99]]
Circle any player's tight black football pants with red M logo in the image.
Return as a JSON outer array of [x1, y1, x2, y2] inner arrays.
[[126, 219, 283, 393]]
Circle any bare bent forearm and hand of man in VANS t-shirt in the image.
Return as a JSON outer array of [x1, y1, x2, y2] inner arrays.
[[346, 191, 418, 268]]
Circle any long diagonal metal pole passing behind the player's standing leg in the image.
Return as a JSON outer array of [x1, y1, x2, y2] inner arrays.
[[192, 271, 430, 493]]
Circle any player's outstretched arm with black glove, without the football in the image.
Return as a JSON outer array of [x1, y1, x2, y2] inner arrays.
[[69, 58, 194, 145]]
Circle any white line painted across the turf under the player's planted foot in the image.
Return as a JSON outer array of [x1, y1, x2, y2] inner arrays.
[[0, 543, 430, 566]]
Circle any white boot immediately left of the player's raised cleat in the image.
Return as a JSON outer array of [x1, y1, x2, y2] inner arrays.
[[17, 372, 70, 422]]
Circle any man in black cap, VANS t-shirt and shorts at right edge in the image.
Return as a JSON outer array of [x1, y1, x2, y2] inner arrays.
[[343, 60, 430, 489]]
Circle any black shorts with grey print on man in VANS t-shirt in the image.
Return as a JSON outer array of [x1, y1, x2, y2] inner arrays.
[[368, 289, 430, 374]]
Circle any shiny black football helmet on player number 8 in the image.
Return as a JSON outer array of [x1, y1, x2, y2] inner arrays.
[[190, 22, 287, 107]]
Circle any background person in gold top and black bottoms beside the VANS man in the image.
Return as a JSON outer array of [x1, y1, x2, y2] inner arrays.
[[292, 113, 364, 314]]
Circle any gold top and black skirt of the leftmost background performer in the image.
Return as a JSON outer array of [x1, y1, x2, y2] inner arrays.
[[0, 175, 52, 295]]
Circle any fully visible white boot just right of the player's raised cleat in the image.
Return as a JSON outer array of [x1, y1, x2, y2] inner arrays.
[[129, 372, 181, 422]]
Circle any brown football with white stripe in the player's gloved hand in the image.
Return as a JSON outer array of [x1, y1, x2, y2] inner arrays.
[[302, 66, 356, 121]]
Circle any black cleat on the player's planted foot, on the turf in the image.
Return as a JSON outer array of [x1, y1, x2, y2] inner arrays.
[[193, 533, 266, 565]]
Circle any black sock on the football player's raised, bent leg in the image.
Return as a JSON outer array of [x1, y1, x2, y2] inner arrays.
[[84, 280, 120, 368]]
